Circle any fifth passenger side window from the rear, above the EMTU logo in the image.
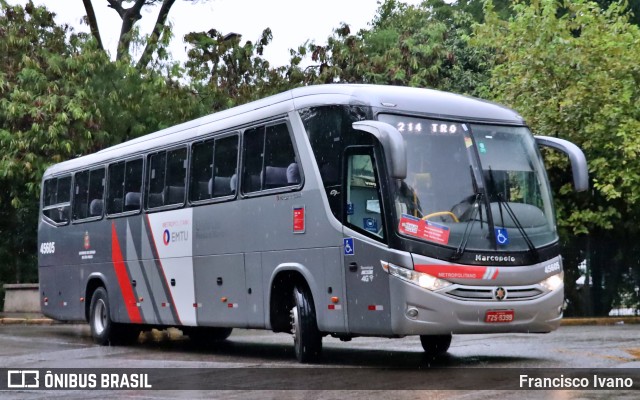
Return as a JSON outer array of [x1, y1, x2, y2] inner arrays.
[[189, 135, 238, 201]]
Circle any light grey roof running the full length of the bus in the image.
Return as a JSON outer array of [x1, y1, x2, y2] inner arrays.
[[44, 84, 524, 177]]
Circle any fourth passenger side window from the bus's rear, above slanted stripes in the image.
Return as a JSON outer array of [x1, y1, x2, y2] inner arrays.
[[147, 147, 187, 208]]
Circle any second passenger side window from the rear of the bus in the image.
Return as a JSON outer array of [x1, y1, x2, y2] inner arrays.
[[73, 168, 104, 221]]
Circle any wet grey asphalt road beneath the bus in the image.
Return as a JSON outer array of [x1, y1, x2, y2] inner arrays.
[[0, 324, 640, 399]]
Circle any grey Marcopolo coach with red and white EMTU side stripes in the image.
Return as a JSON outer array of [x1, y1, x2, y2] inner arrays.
[[38, 84, 588, 362]]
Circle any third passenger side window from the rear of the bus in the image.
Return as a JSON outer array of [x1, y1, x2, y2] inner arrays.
[[107, 158, 142, 214]]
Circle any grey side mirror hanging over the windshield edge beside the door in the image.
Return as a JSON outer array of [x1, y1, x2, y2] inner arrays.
[[352, 121, 407, 179]]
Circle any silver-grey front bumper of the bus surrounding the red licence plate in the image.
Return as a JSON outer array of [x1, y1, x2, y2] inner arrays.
[[390, 278, 564, 336]]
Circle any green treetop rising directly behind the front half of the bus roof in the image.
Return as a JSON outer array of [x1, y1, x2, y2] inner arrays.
[[288, 0, 492, 94]]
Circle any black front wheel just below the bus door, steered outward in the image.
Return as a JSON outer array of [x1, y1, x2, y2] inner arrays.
[[291, 286, 322, 363]]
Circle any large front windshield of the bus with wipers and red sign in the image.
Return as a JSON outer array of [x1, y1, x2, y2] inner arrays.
[[379, 114, 557, 252]]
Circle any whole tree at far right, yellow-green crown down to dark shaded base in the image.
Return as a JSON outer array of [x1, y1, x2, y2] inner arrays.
[[476, 0, 640, 314]]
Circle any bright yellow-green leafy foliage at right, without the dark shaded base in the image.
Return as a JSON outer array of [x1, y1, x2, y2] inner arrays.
[[477, 0, 640, 231]]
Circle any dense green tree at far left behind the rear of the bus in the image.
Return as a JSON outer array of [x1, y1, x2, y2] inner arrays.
[[0, 0, 204, 292]]
